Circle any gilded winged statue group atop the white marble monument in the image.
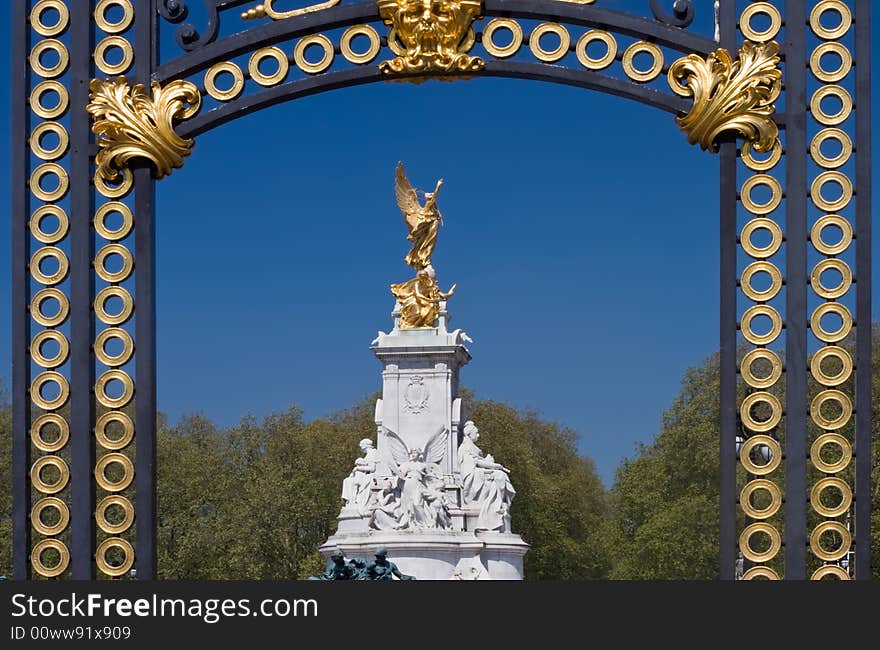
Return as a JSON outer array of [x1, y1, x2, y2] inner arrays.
[[391, 163, 455, 329]]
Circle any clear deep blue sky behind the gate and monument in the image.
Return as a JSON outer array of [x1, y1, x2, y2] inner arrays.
[[0, 0, 880, 483]]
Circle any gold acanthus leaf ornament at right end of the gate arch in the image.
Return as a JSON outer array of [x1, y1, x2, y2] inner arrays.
[[669, 41, 782, 153]]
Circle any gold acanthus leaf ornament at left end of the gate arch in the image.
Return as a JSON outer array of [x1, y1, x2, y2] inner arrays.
[[87, 77, 202, 181]]
